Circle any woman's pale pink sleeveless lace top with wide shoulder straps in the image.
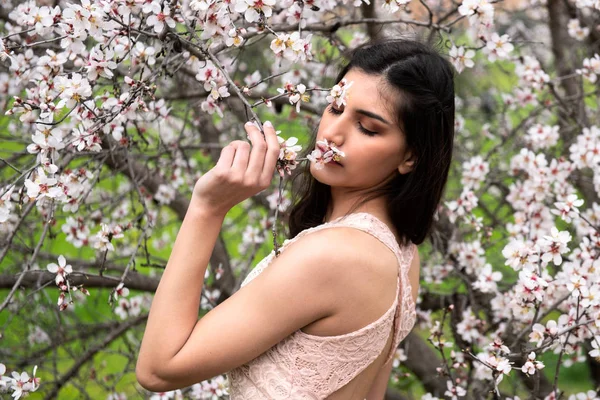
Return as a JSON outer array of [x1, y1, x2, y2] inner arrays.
[[227, 213, 416, 400]]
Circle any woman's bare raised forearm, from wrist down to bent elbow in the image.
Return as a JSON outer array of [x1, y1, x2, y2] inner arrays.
[[138, 205, 224, 371]]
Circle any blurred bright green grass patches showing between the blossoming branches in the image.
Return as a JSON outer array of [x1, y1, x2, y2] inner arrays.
[[0, 26, 593, 399]]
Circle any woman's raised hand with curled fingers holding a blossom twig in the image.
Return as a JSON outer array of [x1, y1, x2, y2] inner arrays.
[[190, 121, 280, 216]]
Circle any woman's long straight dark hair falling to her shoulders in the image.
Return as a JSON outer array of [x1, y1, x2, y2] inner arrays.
[[289, 39, 454, 245]]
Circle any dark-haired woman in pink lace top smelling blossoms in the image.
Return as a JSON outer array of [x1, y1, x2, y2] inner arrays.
[[136, 40, 454, 400]]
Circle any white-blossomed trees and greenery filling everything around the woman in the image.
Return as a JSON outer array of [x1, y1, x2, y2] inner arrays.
[[0, 0, 600, 400]]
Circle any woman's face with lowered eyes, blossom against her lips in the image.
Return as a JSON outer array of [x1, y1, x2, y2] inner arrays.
[[310, 69, 413, 191]]
